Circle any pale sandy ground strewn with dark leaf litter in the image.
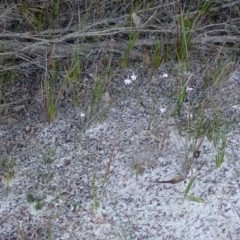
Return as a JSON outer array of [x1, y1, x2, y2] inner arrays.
[[0, 70, 240, 240]]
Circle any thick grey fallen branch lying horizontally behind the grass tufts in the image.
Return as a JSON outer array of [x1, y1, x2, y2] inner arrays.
[[0, 34, 240, 63]]
